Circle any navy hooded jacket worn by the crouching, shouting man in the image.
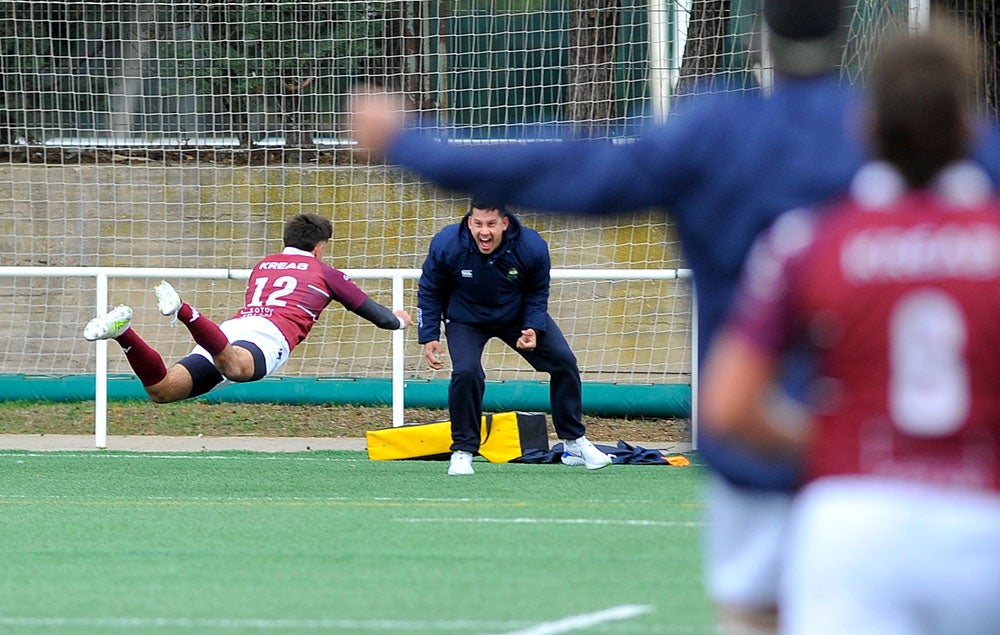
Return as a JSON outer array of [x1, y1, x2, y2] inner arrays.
[[417, 212, 551, 344]]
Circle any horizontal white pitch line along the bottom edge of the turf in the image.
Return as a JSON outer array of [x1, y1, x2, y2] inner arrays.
[[0, 616, 532, 632]]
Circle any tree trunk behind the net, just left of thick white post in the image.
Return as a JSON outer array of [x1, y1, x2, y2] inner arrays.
[[565, 0, 621, 136]]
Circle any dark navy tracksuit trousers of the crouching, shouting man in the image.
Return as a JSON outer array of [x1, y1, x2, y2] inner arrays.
[[445, 317, 586, 454]]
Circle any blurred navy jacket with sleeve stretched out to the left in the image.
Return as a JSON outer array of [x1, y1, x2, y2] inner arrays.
[[388, 74, 1000, 489]]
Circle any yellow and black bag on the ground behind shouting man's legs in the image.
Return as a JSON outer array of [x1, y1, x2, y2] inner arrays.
[[365, 412, 549, 463]]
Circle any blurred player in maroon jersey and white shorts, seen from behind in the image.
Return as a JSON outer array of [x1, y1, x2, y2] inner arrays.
[[704, 27, 1000, 635]]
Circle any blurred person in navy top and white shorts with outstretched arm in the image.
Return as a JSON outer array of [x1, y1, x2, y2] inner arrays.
[[353, 0, 863, 634]]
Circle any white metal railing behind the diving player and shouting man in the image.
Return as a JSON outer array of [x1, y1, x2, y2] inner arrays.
[[0, 267, 698, 449]]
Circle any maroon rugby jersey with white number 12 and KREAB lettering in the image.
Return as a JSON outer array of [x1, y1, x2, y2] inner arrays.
[[236, 247, 368, 350]]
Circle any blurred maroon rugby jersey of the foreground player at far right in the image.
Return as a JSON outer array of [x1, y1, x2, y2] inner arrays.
[[733, 164, 1000, 490]]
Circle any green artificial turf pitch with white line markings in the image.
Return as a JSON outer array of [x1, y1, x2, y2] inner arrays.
[[0, 451, 712, 635]]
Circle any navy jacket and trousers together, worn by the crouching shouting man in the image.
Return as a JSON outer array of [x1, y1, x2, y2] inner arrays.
[[417, 211, 584, 453]]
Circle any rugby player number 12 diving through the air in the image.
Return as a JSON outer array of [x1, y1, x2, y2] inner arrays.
[[83, 214, 413, 403]]
